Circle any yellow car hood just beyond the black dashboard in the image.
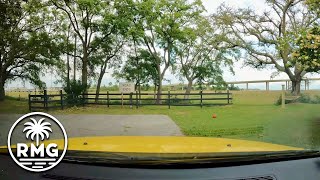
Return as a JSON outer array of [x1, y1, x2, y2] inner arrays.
[[2, 136, 303, 153]]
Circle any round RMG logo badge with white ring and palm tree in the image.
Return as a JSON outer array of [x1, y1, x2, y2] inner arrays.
[[7, 112, 68, 172]]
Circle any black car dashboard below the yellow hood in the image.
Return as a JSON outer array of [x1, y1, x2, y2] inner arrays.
[[0, 155, 320, 180]]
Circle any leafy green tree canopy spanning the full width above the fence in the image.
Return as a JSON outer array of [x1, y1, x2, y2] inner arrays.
[[0, 0, 320, 103]]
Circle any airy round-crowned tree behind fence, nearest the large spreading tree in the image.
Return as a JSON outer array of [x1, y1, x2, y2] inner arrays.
[[176, 17, 234, 98]]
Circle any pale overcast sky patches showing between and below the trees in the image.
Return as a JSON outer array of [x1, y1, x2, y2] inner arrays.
[[8, 0, 320, 89]]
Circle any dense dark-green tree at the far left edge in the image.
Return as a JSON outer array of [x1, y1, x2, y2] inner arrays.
[[0, 0, 60, 101]]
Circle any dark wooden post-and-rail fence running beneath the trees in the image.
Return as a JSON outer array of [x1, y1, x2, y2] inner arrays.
[[29, 90, 233, 111]]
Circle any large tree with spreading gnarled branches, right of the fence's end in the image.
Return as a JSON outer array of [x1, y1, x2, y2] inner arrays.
[[213, 0, 318, 95]]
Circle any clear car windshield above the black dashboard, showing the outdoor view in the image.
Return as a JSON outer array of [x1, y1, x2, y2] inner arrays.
[[0, 0, 320, 162]]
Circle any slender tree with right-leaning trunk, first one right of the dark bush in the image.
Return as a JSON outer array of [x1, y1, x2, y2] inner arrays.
[[89, 0, 130, 102]]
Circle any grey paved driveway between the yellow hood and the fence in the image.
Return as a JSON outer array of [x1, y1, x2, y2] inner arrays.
[[0, 114, 183, 145]]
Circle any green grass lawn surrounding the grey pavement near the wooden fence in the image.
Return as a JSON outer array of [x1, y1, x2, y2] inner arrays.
[[0, 91, 320, 149]]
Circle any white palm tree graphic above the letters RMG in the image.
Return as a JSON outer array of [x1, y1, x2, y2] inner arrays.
[[22, 118, 52, 146]]
